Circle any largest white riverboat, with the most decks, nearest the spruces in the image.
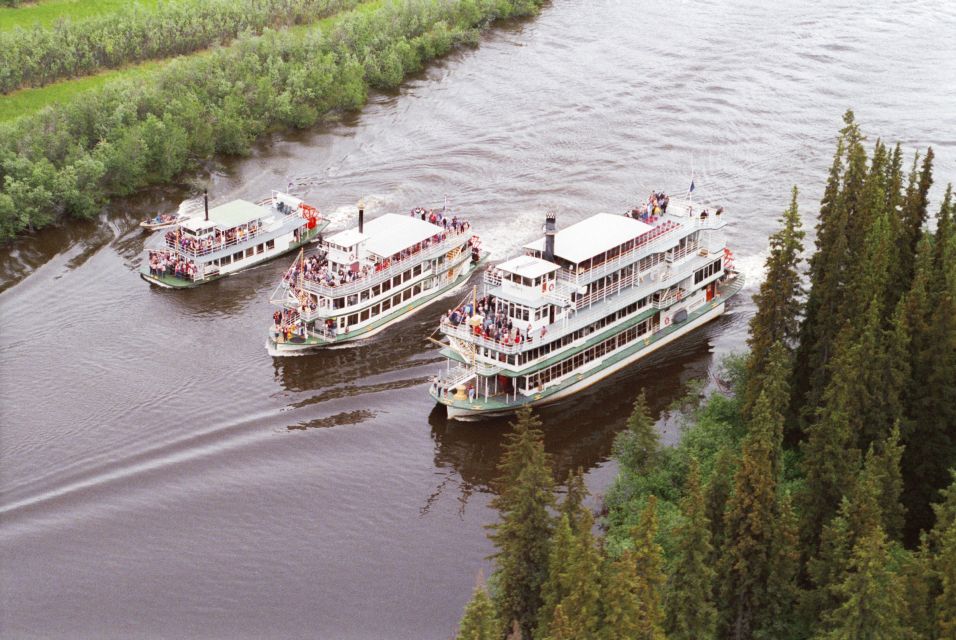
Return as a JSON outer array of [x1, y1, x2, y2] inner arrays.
[[429, 194, 744, 420]]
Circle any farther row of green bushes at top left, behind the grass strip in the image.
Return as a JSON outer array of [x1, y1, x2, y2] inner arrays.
[[0, 0, 359, 93]]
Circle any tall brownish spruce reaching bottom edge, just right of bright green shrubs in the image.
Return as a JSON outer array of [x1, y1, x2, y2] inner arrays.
[[720, 393, 782, 640]]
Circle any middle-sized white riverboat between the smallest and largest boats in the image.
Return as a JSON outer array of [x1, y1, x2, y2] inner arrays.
[[266, 206, 486, 356]]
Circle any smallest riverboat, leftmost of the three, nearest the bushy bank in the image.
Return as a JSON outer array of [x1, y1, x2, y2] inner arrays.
[[140, 191, 329, 289]]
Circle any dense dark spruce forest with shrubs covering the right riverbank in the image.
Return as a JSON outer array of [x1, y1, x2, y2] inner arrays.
[[458, 112, 956, 640]]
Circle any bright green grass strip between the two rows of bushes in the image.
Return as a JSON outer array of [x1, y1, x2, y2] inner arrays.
[[0, 0, 385, 122]]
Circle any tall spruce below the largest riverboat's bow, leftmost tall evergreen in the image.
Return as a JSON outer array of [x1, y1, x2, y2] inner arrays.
[[489, 408, 554, 638]]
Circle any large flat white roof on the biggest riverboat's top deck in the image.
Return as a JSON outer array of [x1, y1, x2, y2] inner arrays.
[[525, 213, 653, 263]]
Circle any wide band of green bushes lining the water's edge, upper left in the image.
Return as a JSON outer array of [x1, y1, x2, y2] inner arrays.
[[0, 0, 543, 240]]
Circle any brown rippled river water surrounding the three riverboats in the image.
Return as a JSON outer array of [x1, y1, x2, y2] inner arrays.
[[0, 0, 956, 640]]
